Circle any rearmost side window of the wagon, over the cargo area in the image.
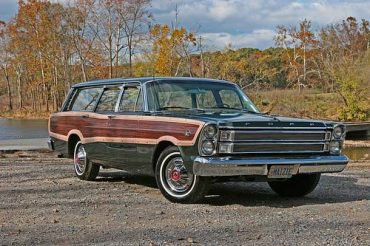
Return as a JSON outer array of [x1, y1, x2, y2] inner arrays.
[[69, 88, 103, 111]]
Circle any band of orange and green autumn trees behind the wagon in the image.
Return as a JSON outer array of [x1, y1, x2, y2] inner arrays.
[[0, 0, 370, 120]]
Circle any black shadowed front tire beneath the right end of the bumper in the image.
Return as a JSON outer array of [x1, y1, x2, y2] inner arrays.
[[268, 173, 321, 197]]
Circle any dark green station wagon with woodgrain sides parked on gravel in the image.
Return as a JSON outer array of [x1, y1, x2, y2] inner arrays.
[[49, 77, 348, 203]]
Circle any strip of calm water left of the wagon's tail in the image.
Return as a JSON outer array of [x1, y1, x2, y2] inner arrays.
[[0, 119, 48, 140]]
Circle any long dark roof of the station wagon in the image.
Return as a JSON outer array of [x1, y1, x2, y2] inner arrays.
[[72, 77, 233, 88]]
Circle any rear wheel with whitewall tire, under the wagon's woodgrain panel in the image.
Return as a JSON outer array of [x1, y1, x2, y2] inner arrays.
[[73, 141, 100, 180]]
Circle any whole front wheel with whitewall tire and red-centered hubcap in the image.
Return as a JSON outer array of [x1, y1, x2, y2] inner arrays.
[[155, 146, 209, 203]]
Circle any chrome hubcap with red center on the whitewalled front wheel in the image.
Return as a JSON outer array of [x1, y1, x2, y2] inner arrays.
[[165, 157, 194, 193]]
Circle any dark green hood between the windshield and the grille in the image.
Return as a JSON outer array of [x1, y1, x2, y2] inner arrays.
[[165, 112, 332, 128]]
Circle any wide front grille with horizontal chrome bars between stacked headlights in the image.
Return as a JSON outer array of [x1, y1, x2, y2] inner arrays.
[[219, 128, 331, 154]]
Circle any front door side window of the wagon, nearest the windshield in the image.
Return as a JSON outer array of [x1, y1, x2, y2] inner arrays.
[[118, 87, 143, 112]]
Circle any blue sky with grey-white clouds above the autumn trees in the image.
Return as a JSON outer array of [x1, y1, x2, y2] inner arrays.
[[0, 0, 370, 49]]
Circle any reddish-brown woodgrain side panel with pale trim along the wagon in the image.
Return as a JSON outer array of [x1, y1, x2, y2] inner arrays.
[[49, 112, 205, 146]]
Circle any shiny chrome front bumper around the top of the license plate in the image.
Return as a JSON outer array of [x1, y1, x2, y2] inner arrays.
[[193, 155, 349, 176]]
